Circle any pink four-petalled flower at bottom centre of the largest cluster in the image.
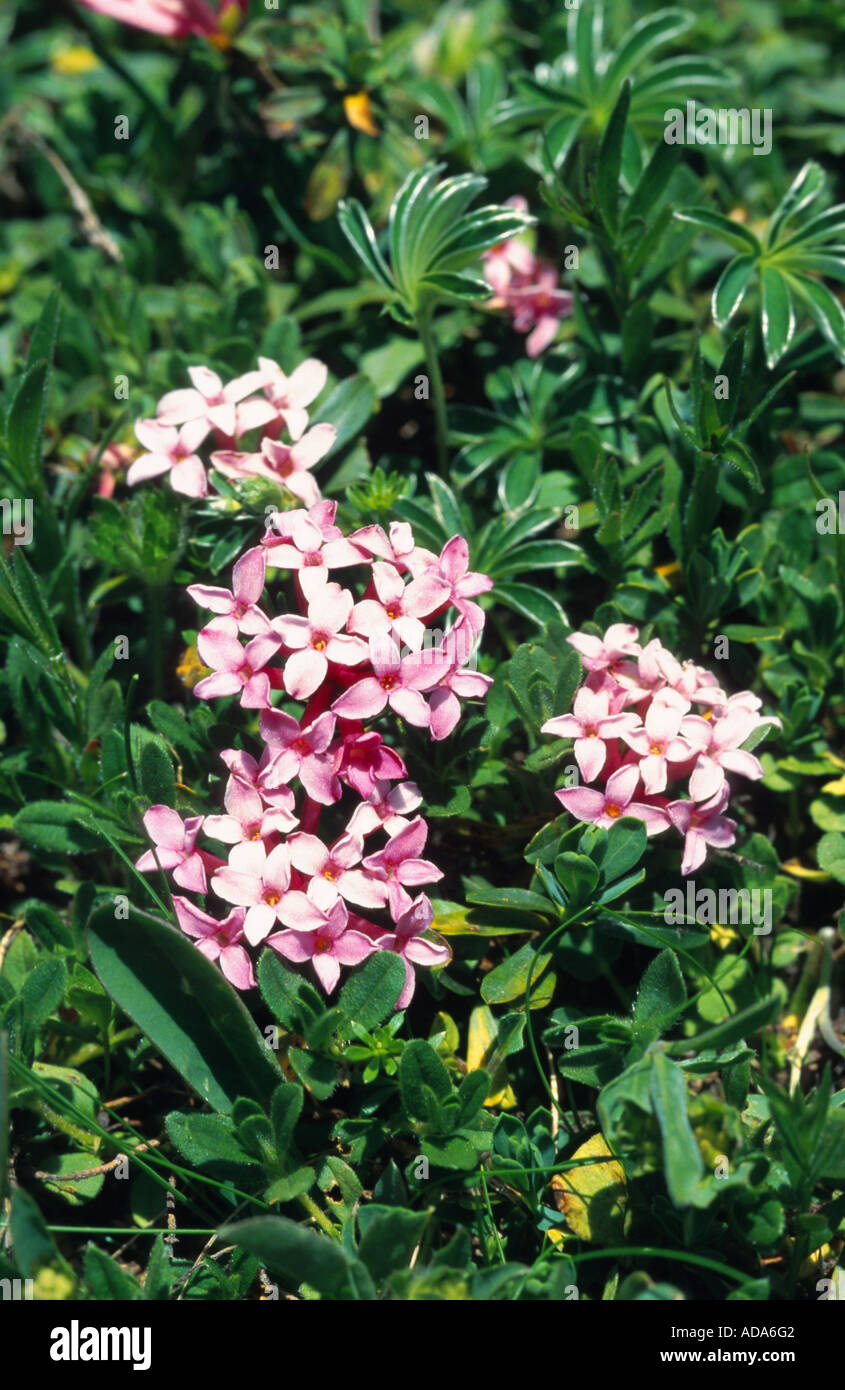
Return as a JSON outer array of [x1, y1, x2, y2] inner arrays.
[[267, 878, 375, 994]]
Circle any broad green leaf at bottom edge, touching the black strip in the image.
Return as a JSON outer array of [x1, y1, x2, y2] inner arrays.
[[220, 1216, 375, 1300]]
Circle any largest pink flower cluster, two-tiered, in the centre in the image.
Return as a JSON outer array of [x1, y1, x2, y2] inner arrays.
[[136, 502, 492, 1008]]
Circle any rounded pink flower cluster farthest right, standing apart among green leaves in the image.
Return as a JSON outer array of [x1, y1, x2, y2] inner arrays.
[[542, 623, 781, 874]]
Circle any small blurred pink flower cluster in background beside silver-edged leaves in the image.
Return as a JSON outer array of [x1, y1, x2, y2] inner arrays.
[[482, 197, 573, 357]]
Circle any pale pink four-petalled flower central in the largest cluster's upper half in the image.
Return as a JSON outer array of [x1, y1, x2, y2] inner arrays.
[[272, 584, 368, 699]]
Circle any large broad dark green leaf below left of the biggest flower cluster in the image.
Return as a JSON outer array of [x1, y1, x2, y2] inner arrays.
[[88, 904, 279, 1113]]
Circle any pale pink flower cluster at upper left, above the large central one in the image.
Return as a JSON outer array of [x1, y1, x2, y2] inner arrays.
[[126, 357, 338, 507]]
